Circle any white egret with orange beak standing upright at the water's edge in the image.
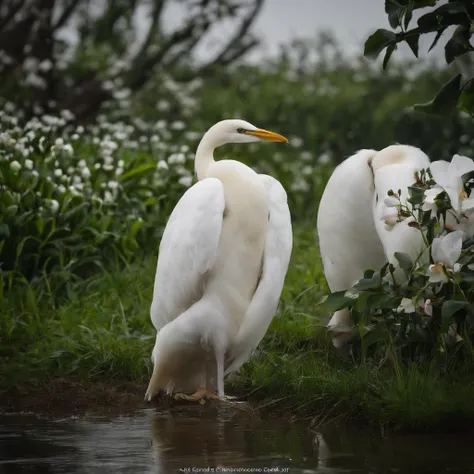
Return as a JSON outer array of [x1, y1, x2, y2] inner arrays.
[[145, 120, 292, 400]]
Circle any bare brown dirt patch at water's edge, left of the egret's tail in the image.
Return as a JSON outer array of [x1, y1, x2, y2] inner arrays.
[[0, 378, 150, 415]]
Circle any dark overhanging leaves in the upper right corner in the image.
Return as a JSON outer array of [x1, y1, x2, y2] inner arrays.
[[364, 0, 474, 116]]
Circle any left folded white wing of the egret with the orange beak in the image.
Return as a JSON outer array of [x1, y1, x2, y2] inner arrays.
[[150, 178, 225, 331]]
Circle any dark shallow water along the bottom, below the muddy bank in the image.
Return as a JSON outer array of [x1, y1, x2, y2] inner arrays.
[[0, 405, 474, 474]]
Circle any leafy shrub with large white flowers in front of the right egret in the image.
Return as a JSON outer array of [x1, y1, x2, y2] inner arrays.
[[325, 155, 474, 362]]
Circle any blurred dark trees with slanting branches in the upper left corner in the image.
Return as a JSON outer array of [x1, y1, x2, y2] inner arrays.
[[0, 0, 264, 119]]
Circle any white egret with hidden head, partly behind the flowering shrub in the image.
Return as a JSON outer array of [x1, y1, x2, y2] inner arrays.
[[317, 145, 430, 347]]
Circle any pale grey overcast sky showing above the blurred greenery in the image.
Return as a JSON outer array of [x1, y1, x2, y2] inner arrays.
[[165, 0, 447, 65]]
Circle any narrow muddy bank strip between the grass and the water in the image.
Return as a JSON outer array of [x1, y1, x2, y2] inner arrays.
[[0, 378, 474, 434]]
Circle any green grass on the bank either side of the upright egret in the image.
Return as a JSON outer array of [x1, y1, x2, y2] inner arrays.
[[0, 222, 474, 430]]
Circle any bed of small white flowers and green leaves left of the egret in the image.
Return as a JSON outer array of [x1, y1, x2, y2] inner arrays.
[[0, 104, 194, 289]]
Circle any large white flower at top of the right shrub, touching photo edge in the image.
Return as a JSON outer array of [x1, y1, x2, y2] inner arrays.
[[430, 155, 474, 213]]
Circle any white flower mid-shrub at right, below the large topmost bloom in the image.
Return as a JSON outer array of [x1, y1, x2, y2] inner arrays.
[[428, 231, 462, 283]]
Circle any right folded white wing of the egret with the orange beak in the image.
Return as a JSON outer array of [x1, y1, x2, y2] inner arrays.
[[225, 174, 293, 374]]
